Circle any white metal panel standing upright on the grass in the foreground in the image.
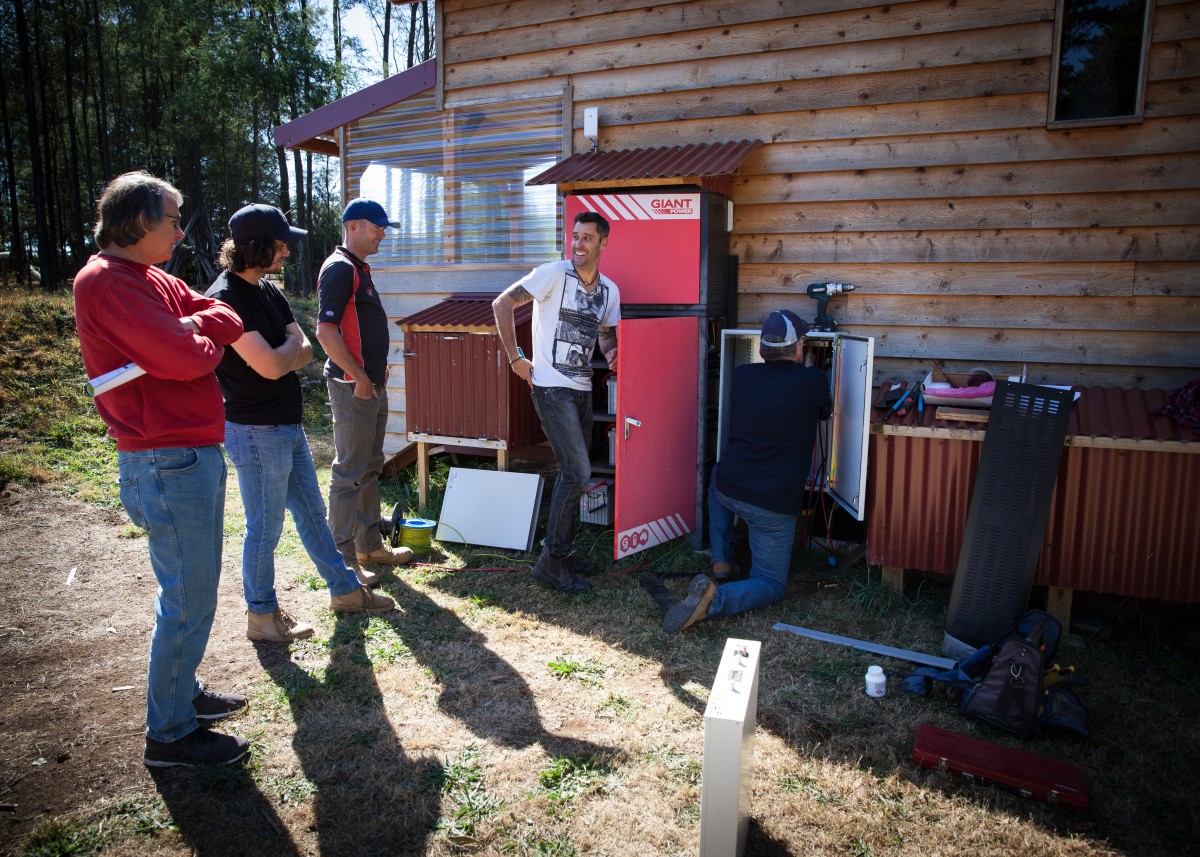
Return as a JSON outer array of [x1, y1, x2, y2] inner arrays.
[[700, 639, 762, 857]]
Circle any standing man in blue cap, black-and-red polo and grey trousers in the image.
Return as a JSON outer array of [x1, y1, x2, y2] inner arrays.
[[317, 198, 413, 565]]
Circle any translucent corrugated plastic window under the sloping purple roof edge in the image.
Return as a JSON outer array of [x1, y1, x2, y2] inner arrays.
[[347, 94, 563, 266]]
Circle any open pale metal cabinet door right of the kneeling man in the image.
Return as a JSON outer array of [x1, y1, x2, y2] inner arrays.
[[818, 332, 875, 521]]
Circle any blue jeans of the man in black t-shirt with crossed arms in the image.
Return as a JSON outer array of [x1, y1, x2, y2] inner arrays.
[[226, 422, 359, 615]]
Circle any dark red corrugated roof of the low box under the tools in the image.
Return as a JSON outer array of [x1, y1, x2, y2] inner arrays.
[[874, 386, 1200, 444]]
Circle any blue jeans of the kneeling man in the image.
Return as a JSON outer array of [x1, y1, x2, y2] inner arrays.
[[707, 468, 796, 616]]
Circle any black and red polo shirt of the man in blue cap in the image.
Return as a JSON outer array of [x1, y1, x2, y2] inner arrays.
[[317, 247, 391, 384]]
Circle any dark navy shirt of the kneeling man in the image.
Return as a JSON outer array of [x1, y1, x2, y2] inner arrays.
[[716, 361, 832, 515]]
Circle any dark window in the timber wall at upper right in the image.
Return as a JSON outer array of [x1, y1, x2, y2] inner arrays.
[[1049, 0, 1154, 125]]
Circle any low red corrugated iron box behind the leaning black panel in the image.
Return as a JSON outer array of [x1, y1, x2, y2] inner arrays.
[[868, 386, 1200, 604]]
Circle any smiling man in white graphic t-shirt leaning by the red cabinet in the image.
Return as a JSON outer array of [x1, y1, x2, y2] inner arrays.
[[492, 211, 620, 594]]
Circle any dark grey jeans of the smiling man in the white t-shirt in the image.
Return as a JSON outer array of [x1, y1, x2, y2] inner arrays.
[[533, 386, 592, 557]]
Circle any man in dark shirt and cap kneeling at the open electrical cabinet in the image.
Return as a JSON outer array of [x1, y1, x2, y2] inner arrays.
[[662, 310, 833, 634]]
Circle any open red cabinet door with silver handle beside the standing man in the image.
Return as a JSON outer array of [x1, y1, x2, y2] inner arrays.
[[613, 317, 701, 559]]
